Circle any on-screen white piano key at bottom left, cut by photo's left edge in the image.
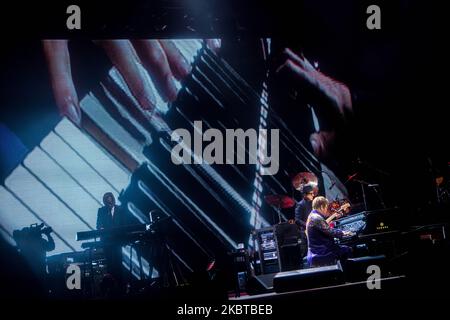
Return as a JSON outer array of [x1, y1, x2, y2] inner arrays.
[[0, 186, 72, 255]]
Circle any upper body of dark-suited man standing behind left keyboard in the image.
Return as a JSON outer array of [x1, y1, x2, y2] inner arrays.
[[97, 192, 126, 230]]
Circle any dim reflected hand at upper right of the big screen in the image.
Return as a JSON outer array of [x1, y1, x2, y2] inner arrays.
[[277, 49, 352, 158]]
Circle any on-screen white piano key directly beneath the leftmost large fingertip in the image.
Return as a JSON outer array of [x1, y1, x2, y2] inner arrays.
[[53, 118, 130, 189]]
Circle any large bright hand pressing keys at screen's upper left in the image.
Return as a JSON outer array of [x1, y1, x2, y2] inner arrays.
[[43, 39, 220, 125]]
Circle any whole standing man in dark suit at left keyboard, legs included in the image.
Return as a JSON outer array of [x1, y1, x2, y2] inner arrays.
[[97, 192, 125, 296]]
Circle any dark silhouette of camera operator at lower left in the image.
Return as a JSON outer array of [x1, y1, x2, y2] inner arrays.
[[13, 223, 55, 284]]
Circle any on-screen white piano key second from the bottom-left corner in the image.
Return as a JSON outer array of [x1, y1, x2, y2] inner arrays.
[[5, 165, 88, 252]]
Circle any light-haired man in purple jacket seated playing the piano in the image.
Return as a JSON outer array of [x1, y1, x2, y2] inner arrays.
[[306, 196, 352, 267]]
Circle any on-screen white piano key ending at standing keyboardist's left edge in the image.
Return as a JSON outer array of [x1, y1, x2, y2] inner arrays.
[[24, 148, 98, 230]]
